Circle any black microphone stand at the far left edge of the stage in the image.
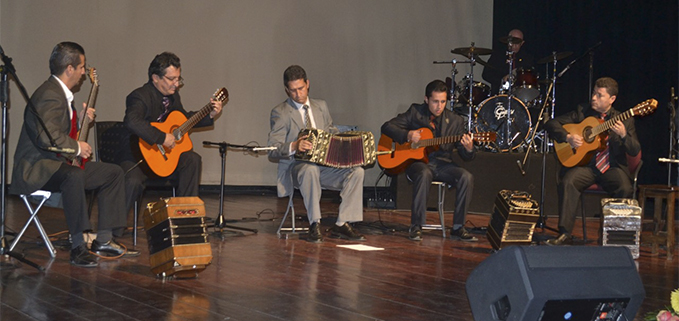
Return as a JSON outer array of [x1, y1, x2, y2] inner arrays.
[[0, 47, 44, 272]]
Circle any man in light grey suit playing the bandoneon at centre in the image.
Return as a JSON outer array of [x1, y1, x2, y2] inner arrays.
[[268, 65, 365, 243]]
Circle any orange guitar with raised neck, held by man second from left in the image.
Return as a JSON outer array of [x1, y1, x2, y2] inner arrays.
[[139, 87, 229, 177]]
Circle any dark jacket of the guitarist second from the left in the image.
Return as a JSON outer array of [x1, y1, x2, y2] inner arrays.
[[121, 81, 214, 162]]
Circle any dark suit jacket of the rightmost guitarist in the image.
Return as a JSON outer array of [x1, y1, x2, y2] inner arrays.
[[545, 105, 641, 178]]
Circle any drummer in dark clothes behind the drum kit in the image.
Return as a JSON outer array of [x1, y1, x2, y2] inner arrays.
[[482, 29, 535, 95]]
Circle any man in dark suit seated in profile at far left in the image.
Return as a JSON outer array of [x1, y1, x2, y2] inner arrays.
[[10, 42, 139, 267]]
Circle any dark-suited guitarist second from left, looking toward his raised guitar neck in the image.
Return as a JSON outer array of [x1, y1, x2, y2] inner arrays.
[[120, 52, 222, 224]]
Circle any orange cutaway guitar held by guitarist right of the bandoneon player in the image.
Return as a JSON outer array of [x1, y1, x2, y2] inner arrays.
[[377, 127, 496, 175]]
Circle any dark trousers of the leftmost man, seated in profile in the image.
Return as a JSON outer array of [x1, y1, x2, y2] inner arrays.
[[42, 162, 127, 235]]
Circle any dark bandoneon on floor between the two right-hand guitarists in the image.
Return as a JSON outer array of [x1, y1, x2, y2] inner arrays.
[[486, 190, 540, 250]]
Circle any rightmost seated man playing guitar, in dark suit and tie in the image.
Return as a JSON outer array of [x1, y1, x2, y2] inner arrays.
[[545, 77, 641, 245]]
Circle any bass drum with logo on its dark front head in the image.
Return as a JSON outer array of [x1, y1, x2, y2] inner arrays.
[[476, 95, 531, 152]]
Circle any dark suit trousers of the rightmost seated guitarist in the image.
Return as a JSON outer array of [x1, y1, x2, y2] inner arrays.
[[557, 166, 633, 234]]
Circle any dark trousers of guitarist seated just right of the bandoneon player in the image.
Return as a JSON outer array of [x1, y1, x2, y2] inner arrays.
[[406, 159, 474, 226]]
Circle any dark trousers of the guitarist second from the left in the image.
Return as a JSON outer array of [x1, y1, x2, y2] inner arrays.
[[120, 151, 202, 211]]
